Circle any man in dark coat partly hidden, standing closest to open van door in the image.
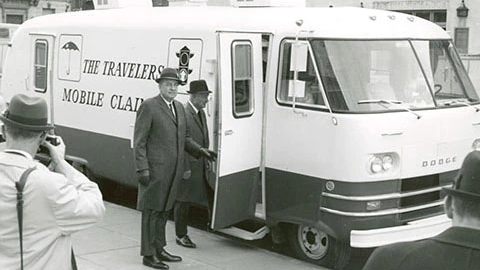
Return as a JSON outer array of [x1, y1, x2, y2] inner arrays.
[[174, 80, 215, 248]]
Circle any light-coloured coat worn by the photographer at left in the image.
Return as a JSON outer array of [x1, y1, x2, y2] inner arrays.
[[0, 151, 105, 270]]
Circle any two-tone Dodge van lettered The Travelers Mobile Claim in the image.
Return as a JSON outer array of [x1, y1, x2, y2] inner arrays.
[[1, 3, 480, 269]]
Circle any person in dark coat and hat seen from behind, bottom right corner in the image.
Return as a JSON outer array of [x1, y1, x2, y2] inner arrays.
[[363, 151, 480, 270]]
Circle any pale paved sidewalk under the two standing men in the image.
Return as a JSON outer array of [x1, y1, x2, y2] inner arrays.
[[73, 202, 325, 270]]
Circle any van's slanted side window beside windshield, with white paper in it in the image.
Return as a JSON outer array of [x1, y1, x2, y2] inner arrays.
[[277, 40, 325, 107]]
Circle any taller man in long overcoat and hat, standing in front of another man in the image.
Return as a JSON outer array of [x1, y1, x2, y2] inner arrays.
[[134, 68, 210, 269]]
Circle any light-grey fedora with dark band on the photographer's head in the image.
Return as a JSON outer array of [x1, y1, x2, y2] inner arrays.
[[0, 94, 53, 131]]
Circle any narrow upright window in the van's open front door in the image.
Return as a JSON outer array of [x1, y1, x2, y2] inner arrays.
[[232, 41, 253, 117]]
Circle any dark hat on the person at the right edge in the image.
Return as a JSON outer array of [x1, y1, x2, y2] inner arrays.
[[444, 151, 480, 200]]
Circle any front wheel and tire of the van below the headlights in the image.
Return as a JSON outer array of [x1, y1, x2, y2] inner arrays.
[[288, 224, 351, 270]]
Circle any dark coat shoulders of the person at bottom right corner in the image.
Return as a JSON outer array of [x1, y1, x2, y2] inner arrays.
[[363, 227, 480, 270]]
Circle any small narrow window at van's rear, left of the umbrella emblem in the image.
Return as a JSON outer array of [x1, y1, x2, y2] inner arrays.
[[34, 39, 48, 93]]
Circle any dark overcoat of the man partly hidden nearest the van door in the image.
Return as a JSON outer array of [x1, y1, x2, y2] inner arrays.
[[177, 102, 210, 206]]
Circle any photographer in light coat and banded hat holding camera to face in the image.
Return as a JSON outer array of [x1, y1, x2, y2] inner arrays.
[[0, 94, 105, 270]]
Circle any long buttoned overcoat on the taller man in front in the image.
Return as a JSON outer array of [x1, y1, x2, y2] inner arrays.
[[134, 95, 200, 211]]
